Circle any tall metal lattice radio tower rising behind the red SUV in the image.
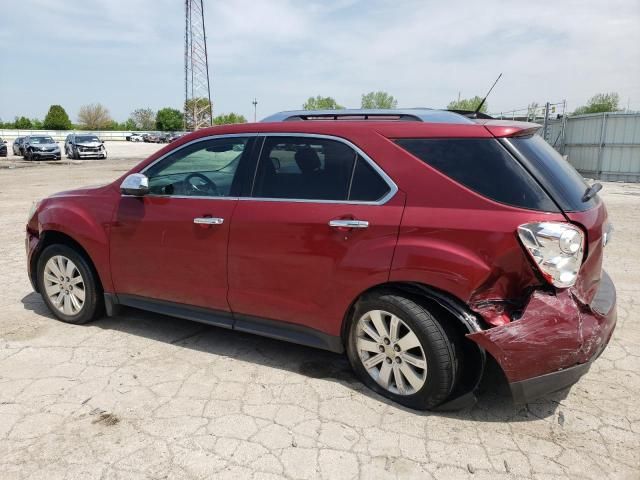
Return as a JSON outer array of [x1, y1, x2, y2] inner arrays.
[[184, 0, 213, 130]]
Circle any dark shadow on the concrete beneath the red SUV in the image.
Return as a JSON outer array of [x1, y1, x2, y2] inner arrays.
[[22, 292, 568, 422]]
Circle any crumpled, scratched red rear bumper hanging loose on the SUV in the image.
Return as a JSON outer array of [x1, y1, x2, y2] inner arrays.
[[468, 272, 617, 403]]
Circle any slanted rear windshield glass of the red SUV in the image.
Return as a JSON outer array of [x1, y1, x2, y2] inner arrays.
[[508, 135, 598, 212]]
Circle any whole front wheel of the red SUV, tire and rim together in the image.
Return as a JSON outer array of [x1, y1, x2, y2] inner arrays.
[[37, 245, 104, 324]]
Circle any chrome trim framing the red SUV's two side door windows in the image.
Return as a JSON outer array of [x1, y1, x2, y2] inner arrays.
[[127, 132, 398, 205]]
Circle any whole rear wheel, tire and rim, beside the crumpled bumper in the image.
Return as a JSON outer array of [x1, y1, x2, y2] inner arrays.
[[347, 292, 459, 410]]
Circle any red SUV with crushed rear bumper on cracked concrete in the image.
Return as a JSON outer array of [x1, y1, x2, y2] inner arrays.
[[26, 110, 616, 409]]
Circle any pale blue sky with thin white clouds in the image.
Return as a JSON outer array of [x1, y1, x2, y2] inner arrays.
[[0, 0, 640, 121]]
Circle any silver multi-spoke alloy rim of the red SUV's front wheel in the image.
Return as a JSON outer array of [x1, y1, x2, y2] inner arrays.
[[43, 255, 86, 316]]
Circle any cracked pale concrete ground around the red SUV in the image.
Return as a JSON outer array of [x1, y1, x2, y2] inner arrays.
[[0, 145, 640, 480]]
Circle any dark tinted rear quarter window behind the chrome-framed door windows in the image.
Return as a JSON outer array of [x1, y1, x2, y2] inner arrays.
[[397, 138, 558, 212]]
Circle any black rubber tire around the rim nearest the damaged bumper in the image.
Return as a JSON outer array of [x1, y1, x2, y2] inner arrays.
[[347, 291, 461, 410]]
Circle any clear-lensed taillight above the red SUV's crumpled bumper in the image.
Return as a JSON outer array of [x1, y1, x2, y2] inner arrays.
[[518, 222, 584, 288]]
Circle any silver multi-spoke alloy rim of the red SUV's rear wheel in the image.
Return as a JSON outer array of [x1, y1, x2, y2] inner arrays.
[[356, 310, 427, 395]]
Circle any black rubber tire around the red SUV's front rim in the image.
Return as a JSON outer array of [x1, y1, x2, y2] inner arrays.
[[37, 244, 104, 325]]
